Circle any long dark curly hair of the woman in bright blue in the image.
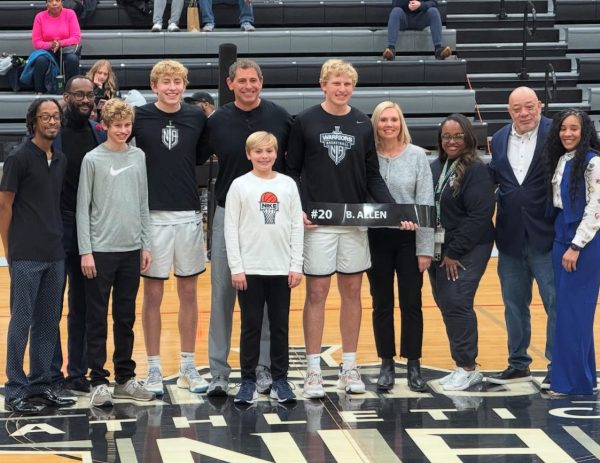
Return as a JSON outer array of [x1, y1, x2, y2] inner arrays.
[[544, 108, 600, 201]]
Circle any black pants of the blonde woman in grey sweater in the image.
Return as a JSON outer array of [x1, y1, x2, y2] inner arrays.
[[367, 228, 423, 360]]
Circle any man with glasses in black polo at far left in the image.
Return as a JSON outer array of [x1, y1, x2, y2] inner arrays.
[[0, 98, 75, 414]]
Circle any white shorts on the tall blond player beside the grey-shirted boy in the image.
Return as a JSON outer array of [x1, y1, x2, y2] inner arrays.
[[142, 211, 206, 280]]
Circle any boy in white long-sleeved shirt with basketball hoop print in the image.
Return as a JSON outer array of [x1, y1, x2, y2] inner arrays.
[[225, 131, 304, 404]]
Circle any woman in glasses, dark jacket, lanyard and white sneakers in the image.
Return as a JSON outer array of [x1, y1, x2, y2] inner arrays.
[[429, 114, 495, 391]]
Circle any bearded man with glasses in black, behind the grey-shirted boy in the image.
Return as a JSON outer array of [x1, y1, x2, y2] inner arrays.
[[52, 76, 106, 397]]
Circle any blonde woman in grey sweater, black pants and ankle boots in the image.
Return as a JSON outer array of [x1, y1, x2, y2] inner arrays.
[[367, 101, 433, 392]]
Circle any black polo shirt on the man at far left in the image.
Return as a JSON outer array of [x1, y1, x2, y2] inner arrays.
[[0, 139, 67, 262]]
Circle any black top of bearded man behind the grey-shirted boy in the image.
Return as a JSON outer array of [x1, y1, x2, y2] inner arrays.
[[61, 121, 98, 213]]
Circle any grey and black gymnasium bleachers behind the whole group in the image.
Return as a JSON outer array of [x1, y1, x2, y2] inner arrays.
[[0, 0, 600, 167]]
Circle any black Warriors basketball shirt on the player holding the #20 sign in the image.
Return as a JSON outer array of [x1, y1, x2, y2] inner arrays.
[[286, 105, 395, 208]]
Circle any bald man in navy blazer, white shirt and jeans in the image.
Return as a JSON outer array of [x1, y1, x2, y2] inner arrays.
[[487, 87, 556, 389]]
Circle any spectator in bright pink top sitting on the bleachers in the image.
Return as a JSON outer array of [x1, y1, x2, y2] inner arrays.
[[31, 0, 81, 93]]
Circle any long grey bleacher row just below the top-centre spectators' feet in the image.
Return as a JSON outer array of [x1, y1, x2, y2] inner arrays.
[[0, 28, 456, 59]]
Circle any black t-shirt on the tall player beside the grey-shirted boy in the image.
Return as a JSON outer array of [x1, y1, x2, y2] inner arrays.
[[132, 103, 206, 211]]
